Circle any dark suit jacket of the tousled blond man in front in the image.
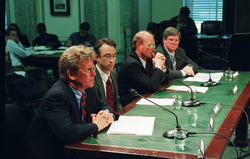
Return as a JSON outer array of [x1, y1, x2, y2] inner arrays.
[[30, 80, 117, 159]]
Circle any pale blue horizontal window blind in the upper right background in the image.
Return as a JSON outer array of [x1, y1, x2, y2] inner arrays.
[[185, 0, 223, 33]]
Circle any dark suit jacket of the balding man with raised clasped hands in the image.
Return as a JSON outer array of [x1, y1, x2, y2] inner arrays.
[[118, 52, 167, 107]]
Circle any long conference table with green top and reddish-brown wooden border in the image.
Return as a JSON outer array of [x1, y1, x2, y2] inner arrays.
[[65, 72, 250, 158]]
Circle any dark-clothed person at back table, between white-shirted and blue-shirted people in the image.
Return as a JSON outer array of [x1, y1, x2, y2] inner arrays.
[[32, 23, 62, 47]]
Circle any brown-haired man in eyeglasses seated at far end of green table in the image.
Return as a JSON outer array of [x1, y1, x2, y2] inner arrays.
[[154, 27, 198, 78]]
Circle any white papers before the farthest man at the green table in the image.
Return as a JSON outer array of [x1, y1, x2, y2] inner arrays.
[[184, 72, 223, 82]]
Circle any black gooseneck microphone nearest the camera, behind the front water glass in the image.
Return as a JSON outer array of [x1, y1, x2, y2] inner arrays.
[[129, 88, 181, 138]]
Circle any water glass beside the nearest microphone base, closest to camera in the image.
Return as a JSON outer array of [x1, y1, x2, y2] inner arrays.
[[174, 128, 186, 150]]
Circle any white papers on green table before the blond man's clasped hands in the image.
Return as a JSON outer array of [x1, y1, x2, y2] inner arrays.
[[107, 116, 155, 136]]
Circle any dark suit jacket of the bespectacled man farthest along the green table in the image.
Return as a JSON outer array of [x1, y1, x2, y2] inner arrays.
[[154, 44, 198, 78]]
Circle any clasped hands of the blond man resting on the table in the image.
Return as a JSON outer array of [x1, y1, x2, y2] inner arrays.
[[90, 109, 114, 132]]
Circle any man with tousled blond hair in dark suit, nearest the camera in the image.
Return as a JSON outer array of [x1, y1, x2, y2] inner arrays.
[[30, 45, 118, 159]]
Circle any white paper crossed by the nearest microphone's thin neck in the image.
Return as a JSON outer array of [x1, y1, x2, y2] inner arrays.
[[136, 98, 174, 105]]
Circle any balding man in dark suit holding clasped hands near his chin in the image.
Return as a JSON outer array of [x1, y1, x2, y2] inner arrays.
[[118, 31, 167, 107]]
